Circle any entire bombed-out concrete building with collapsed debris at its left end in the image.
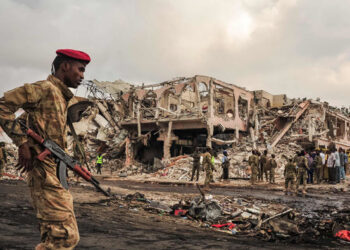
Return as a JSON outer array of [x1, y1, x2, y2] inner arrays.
[[0, 75, 350, 179]]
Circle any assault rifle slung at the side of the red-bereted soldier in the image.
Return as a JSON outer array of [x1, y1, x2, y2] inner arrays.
[[17, 120, 110, 197]]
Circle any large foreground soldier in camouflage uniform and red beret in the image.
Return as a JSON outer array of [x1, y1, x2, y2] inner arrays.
[[0, 50, 90, 250]]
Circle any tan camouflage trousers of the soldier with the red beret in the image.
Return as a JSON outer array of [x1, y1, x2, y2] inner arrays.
[[28, 160, 80, 249]]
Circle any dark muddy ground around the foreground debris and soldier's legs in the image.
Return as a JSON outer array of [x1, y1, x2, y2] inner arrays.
[[0, 180, 350, 249]]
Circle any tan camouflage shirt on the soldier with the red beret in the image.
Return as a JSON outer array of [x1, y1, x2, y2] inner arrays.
[[0, 75, 73, 153]]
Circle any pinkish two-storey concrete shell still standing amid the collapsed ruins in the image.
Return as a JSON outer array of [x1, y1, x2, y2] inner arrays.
[[120, 76, 253, 163]]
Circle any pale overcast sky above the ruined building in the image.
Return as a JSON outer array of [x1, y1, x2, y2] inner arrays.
[[0, 0, 350, 107]]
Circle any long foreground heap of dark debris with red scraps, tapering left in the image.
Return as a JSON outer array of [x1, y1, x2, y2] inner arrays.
[[110, 193, 350, 244]]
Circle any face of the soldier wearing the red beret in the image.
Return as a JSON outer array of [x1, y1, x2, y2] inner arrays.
[[64, 61, 86, 89]]
